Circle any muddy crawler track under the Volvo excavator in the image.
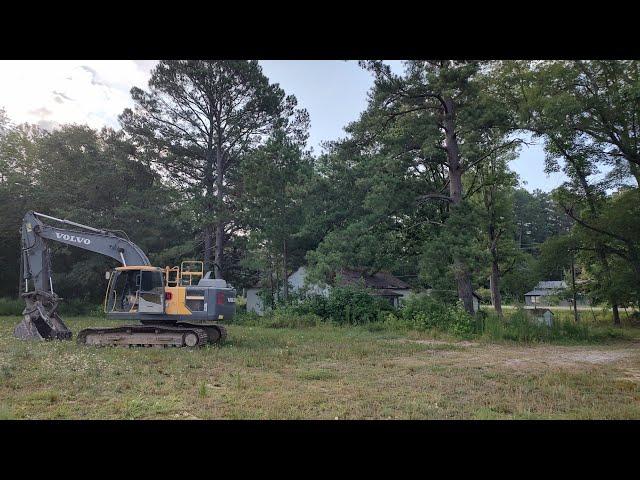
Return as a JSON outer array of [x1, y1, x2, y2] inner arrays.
[[77, 325, 209, 348]]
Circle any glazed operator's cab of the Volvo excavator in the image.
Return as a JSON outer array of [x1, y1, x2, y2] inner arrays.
[[104, 266, 164, 314]]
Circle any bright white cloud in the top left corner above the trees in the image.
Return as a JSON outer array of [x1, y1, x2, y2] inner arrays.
[[0, 60, 156, 128]]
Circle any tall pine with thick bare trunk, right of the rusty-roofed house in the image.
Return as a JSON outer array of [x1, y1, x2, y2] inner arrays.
[[366, 60, 517, 312]]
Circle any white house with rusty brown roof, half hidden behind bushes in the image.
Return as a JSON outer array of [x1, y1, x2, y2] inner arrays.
[[246, 267, 411, 315]]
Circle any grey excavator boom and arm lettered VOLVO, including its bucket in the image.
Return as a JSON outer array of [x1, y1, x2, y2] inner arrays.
[[14, 211, 151, 339]]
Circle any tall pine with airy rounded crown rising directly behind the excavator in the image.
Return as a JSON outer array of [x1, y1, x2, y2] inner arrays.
[[120, 60, 304, 278]]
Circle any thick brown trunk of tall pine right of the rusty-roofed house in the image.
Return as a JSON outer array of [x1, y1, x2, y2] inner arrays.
[[443, 98, 475, 315]]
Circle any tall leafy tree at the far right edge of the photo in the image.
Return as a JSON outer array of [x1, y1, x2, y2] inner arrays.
[[504, 61, 640, 324]]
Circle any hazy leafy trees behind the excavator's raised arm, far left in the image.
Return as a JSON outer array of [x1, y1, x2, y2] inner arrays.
[[0, 125, 192, 304]]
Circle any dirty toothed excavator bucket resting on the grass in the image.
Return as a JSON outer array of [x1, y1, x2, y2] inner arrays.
[[13, 291, 72, 340]]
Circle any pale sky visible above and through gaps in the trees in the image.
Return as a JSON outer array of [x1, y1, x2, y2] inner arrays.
[[0, 60, 564, 191]]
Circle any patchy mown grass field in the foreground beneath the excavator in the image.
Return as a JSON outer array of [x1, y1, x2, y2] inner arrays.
[[0, 317, 640, 419]]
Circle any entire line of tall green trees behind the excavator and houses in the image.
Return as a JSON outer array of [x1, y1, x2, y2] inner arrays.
[[0, 61, 640, 321]]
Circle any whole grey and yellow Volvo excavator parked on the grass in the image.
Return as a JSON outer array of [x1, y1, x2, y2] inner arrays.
[[13, 211, 236, 348]]
